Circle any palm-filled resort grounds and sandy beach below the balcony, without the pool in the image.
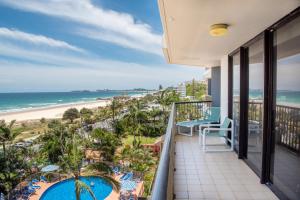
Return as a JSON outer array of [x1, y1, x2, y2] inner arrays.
[[0, 90, 179, 200]]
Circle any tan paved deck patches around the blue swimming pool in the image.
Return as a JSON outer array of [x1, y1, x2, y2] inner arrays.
[[29, 175, 144, 200]]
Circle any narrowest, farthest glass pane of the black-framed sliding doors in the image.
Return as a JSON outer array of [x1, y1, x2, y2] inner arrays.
[[232, 52, 240, 151]]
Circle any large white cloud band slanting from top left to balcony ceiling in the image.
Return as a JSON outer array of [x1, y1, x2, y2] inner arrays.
[[0, 0, 162, 55]]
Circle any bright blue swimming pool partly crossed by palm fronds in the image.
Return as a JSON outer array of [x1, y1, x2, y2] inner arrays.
[[40, 176, 112, 200]]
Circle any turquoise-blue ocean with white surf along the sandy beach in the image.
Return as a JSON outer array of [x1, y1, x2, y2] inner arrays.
[[0, 90, 146, 113]]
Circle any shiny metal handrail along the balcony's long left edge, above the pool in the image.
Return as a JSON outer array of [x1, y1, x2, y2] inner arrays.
[[151, 103, 176, 200]]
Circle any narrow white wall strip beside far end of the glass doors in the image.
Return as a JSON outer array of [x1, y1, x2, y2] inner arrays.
[[221, 55, 228, 122]]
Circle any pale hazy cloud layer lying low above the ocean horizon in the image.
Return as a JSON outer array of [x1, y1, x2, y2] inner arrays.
[[0, 58, 201, 92]]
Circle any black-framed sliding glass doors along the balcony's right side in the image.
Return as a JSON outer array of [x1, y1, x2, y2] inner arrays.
[[228, 7, 300, 200]]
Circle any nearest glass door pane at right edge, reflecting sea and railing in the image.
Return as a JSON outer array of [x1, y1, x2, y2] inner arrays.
[[271, 17, 300, 200]]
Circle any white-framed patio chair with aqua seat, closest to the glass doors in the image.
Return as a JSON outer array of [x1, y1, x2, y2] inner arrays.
[[199, 117, 234, 151]]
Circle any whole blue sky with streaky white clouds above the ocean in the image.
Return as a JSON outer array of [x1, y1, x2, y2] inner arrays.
[[0, 0, 204, 92]]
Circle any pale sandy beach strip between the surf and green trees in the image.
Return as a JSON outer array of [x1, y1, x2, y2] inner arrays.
[[0, 100, 110, 121]]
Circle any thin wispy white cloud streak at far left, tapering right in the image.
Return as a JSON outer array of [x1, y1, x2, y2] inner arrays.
[[0, 27, 85, 52]]
